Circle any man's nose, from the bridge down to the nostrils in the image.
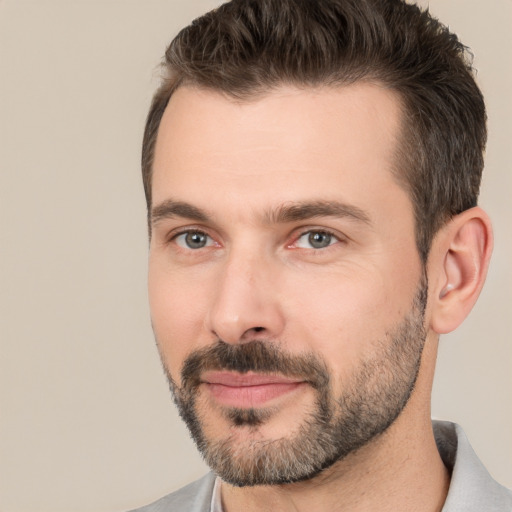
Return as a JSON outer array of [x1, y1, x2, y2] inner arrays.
[[207, 251, 284, 343]]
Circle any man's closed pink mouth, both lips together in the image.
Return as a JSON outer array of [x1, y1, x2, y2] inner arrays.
[[201, 371, 307, 408]]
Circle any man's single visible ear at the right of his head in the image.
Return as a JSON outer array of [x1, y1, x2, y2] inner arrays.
[[429, 207, 493, 334]]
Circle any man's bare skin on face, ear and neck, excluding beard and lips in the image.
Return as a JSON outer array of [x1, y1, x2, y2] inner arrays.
[[149, 83, 491, 512]]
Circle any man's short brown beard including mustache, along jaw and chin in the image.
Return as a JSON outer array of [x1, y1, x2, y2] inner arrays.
[[162, 277, 427, 487]]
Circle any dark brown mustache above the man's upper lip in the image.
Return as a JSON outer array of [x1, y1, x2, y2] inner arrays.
[[181, 340, 329, 391]]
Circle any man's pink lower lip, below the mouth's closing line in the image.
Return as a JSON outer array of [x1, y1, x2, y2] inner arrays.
[[205, 382, 305, 408]]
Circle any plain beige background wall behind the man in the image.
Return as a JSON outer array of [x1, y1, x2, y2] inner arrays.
[[0, 0, 512, 512]]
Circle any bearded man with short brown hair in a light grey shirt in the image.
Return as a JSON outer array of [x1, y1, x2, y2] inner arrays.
[[131, 0, 512, 512]]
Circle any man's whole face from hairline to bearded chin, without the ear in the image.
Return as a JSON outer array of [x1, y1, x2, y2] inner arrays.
[[149, 84, 426, 485]]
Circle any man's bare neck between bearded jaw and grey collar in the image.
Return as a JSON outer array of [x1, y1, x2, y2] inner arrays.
[[222, 419, 449, 512]]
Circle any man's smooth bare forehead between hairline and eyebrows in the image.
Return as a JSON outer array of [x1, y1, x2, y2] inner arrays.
[[152, 83, 408, 218]]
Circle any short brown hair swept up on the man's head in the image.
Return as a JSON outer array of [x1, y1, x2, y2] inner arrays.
[[142, 0, 487, 261]]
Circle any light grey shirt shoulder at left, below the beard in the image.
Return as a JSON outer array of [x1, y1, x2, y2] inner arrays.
[[130, 473, 215, 512]]
